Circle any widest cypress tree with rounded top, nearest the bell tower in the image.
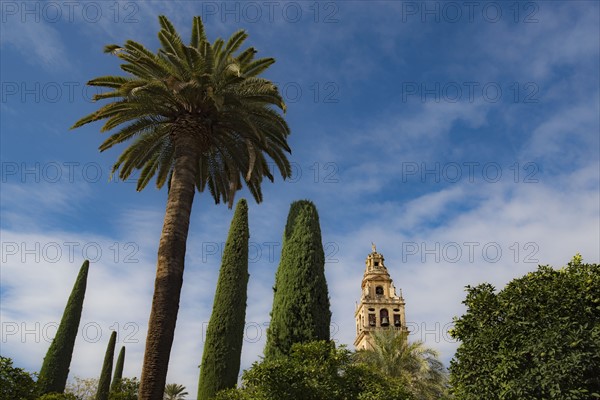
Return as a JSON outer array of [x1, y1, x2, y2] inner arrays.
[[265, 200, 331, 358]]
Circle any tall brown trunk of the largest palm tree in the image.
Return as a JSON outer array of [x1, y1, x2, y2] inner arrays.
[[138, 132, 198, 400]]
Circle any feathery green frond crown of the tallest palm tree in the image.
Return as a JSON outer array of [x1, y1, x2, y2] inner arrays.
[[72, 15, 291, 207]]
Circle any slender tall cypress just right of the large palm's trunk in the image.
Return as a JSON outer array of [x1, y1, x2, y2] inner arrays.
[[198, 199, 250, 400]]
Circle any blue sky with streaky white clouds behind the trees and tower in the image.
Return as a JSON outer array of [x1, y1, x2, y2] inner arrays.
[[0, 1, 600, 398]]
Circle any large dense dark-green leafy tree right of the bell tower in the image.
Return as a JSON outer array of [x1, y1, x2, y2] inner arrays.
[[450, 255, 600, 400]]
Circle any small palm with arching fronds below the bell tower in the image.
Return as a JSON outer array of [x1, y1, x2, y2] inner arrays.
[[356, 329, 448, 400]]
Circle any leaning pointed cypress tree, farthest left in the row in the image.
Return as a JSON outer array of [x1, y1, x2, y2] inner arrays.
[[37, 260, 90, 396]]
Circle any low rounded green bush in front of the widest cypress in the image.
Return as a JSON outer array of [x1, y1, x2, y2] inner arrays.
[[216, 341, 411, 400]]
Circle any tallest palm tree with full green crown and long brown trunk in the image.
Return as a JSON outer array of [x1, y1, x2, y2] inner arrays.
[[72, 16, 291, 400]]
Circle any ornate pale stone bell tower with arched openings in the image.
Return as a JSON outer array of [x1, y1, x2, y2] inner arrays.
[[354, 244, 408, 350]]
